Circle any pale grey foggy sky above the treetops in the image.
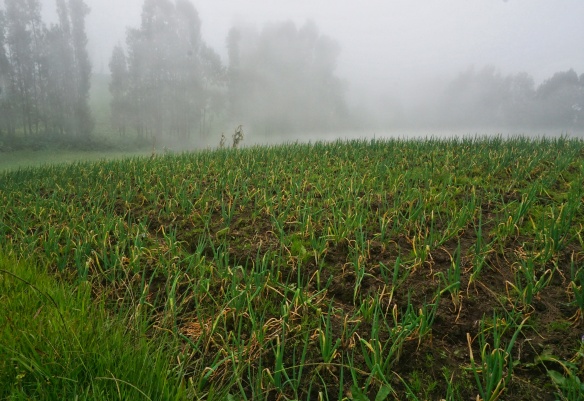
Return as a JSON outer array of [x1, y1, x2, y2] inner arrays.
[[17, 0, 584, 103]]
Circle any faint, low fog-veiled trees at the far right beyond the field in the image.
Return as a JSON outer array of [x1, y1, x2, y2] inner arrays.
[[417, 66, 584, 131]]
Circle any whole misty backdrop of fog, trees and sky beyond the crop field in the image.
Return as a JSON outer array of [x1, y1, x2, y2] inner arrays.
[[0, 0, 584, 150]]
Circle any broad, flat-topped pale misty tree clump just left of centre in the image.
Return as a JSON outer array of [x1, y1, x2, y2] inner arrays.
[[227, 22, 347, 134]]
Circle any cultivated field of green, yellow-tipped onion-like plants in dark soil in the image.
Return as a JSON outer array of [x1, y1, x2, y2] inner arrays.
[[0, 138, 584, 400]]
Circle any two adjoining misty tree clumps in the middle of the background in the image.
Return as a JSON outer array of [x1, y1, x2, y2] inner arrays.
[[109, 0, 346, 141]]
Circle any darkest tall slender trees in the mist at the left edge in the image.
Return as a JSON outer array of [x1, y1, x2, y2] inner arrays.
[[0, 0, 93, 148]]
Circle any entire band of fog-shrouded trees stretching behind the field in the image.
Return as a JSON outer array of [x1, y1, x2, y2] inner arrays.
[[0, 0, 584, 151]]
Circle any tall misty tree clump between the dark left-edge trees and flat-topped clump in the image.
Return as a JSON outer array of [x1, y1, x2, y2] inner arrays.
[[116, 0, 222, 140]]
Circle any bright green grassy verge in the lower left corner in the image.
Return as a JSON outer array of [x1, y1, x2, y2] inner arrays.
[[0, 248, 184, 400]]
